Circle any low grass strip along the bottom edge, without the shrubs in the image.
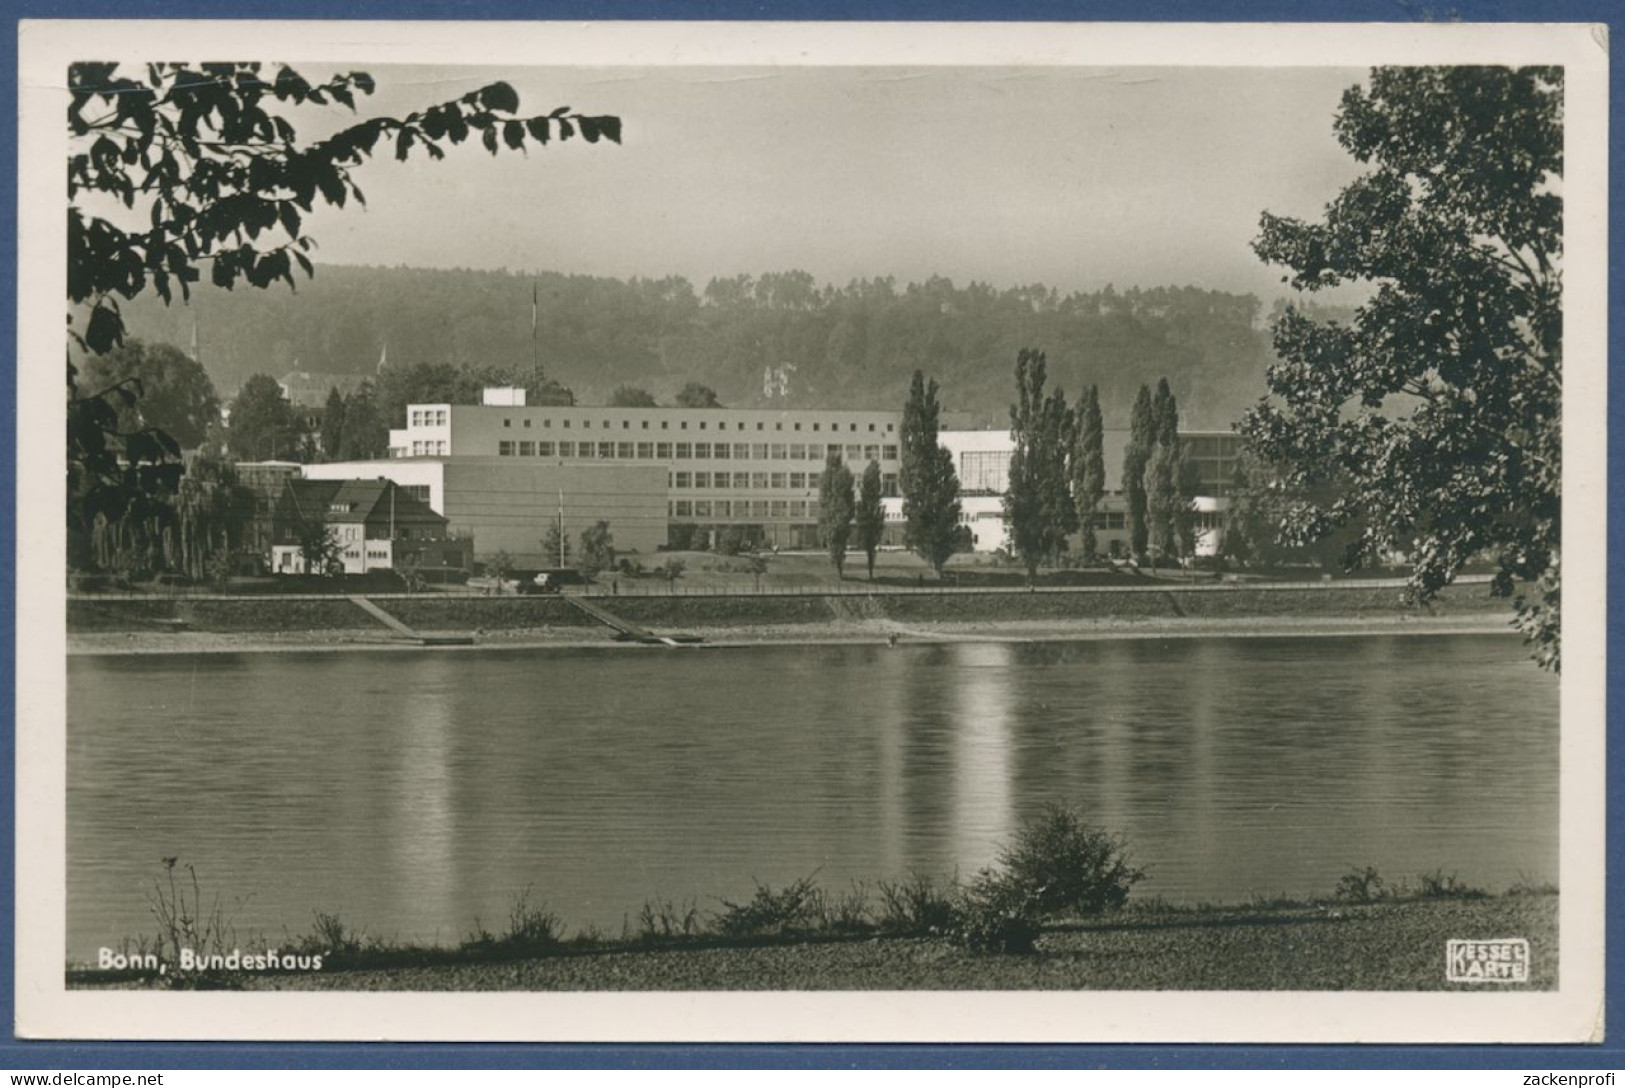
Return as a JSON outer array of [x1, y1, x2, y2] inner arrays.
[[70, 892, 1558, 992]]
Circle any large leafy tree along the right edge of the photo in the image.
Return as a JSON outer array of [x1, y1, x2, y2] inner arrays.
[[1243, 67, 1563, 669]]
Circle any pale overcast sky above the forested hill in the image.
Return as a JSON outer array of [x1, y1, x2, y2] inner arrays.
[[301, 65, 1365, 297]]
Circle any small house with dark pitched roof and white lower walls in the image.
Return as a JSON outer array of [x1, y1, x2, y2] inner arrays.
[[271, 479, 475, 575]]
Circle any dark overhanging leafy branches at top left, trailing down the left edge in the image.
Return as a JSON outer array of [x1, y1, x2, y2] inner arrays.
[[67, 62, 621, 563]]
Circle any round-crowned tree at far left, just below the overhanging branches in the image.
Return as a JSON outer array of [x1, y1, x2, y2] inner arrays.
[[78, 339, 219, 450]]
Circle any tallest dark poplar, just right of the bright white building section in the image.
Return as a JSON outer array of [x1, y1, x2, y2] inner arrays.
[[1004, 348, 1077, 580]]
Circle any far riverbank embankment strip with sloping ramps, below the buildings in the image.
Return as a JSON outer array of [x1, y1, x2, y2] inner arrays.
[[67, 583, 1508, 653]]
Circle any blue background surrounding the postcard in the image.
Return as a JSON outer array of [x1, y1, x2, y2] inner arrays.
[[0, 0, 1625, 1072]]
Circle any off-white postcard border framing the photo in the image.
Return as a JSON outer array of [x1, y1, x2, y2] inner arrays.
[[15, 19, 1609, 1043]]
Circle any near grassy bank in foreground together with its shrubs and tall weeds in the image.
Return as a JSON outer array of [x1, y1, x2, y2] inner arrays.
[[76, 807, 1558, 991]]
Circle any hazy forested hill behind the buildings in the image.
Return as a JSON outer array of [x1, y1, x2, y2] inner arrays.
[[125, 266, 1269, 429]]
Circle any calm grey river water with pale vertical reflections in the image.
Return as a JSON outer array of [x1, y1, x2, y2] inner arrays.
[[67, 635, 1558, 960]]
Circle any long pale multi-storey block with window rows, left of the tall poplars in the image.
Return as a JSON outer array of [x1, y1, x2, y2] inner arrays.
[[360, 390, 949, 554]]
